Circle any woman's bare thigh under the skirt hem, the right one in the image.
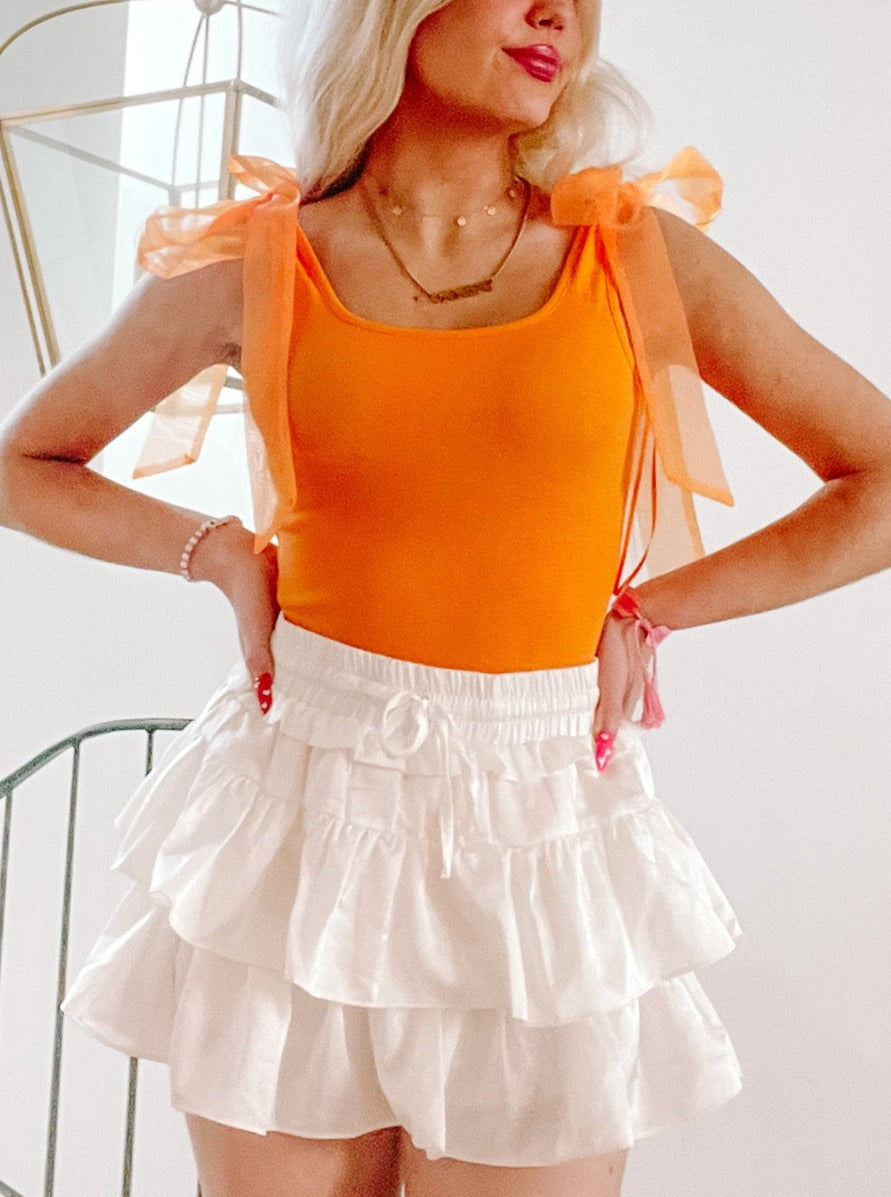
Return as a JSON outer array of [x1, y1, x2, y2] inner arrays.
[[400, 1130, 629, 1197]]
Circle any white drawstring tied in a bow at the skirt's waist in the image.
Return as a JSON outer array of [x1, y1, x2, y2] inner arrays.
[[381, 689, 479, 877]]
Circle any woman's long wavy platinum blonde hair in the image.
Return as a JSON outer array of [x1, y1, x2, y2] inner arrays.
[[278, 0, 649, 199]]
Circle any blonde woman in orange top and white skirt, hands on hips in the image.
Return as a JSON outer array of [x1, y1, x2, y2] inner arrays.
[[0, 0, 891, 1197]]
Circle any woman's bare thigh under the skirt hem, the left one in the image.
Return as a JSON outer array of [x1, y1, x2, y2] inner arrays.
[[186, 1113, 401, 1197]]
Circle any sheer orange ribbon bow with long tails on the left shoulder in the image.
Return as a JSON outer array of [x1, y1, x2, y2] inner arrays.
[[133, 154, 299, 552]]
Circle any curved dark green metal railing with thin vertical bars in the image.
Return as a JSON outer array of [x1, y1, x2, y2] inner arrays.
[[0, 719, 201, 1197]]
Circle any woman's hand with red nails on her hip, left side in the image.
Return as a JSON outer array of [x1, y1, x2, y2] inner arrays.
[[192, 524, 279, 715]]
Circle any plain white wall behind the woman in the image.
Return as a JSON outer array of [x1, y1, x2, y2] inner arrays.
[[0, 0, 891, 1197]]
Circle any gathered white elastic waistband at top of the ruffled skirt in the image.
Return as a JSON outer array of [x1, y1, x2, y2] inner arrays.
[[272, 615, 598, 719]]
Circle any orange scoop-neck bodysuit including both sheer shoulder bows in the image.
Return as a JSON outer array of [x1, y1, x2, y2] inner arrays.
[[134, 147, 733, 673]]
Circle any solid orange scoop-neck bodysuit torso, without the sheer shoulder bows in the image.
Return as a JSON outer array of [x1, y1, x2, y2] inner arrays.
[[278, 227, 634, 673]]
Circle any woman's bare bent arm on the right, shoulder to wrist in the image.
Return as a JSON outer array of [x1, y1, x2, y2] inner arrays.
[[637, 211, 891, 627]]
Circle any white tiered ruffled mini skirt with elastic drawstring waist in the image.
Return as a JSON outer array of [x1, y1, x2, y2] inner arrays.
[[62, 619, 741, 1166]]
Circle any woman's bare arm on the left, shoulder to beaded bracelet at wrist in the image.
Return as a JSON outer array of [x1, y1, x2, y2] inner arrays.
[[0, 261, 249, 581]]
